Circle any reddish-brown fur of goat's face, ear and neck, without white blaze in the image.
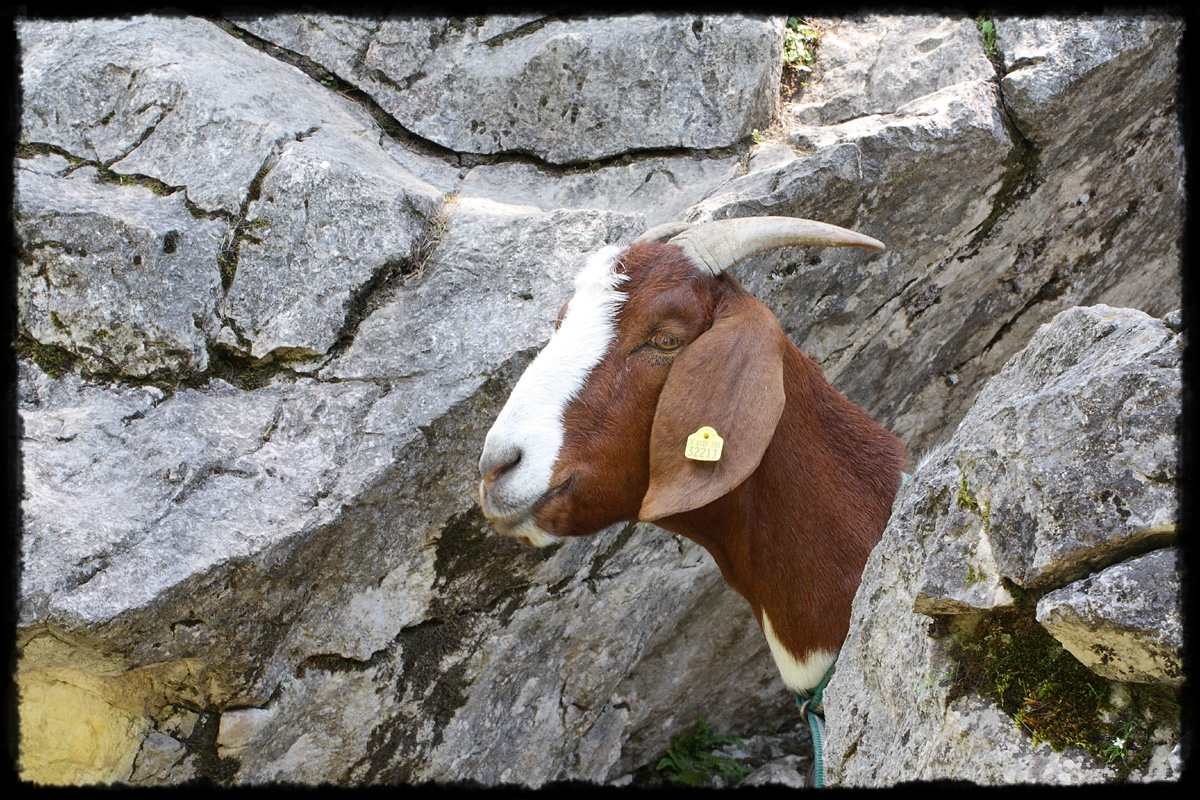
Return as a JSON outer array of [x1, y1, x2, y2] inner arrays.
[[536, 242, 904, 671]]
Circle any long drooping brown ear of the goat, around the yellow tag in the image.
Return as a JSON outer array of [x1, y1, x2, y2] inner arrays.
[[637, 293, 787, 522]]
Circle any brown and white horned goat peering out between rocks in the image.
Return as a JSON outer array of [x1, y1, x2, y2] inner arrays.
[[479, 217, 904, 691]]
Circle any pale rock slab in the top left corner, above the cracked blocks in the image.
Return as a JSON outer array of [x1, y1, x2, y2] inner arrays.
[[18, 17, 386, 215]]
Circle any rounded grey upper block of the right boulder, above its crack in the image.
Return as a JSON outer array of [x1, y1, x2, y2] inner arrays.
[[916, 306, 1182, 613]]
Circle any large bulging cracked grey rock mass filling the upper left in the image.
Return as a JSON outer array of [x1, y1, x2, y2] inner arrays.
[[20, 17, 451, 375]]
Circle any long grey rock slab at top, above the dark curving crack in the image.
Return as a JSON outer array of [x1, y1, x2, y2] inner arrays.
[[238, 14, 782, 163]]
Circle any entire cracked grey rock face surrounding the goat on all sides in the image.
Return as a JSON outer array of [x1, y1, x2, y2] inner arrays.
[[14, 14, 1183, 786]]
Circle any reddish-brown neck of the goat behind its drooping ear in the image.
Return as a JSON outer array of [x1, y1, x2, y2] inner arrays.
[[659, 347, 902, 688]]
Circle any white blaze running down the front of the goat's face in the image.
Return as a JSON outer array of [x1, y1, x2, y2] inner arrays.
[[479, 245, 628, 546]]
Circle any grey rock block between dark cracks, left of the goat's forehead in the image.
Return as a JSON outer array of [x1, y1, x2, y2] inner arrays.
[[221, 131, 443, 359]]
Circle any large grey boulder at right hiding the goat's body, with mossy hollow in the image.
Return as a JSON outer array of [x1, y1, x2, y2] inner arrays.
[[826, 306, 1183, 786]]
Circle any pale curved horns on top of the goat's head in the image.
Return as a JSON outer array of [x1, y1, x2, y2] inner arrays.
[[667, 217, 883, 275]]
